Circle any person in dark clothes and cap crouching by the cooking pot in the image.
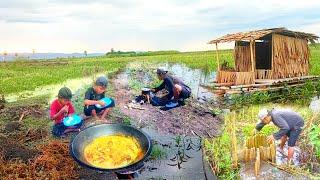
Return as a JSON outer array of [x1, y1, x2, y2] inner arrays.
[[152, 69, 191, 105]]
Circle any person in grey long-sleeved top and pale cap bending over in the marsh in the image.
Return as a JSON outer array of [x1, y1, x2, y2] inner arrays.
[[256, 109, 304, 163]]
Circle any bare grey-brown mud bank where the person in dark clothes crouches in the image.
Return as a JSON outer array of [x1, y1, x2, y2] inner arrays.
[[112, 73, 223, 137]]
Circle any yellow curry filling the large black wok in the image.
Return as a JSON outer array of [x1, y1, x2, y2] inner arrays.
[[84, 135, 143, 169]]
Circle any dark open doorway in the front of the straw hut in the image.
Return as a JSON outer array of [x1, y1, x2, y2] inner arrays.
[[255, 40, 272, 70]]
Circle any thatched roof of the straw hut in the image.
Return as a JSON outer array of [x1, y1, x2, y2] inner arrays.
[[209, 28, 319, 44]]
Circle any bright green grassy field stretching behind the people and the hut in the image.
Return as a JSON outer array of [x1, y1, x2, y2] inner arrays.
[[0, 44, 320, 95]]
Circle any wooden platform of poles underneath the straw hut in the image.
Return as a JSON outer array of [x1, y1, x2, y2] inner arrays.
[[206, 76, 320, 95]]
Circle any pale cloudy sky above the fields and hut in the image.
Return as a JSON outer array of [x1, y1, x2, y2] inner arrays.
[[0, 0, 320, 53]]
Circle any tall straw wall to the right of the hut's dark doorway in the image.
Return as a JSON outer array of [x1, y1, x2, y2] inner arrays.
[[272, 34, 310, 79]]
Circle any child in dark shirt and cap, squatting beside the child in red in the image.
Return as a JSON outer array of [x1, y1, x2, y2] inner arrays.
[[84, 77, 114, 121]]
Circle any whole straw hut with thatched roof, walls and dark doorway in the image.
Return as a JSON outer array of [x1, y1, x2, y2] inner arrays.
[[209, 28, 319, 85]]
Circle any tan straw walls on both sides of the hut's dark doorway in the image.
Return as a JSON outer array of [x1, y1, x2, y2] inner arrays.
[[234, 34, 310, 79]]
